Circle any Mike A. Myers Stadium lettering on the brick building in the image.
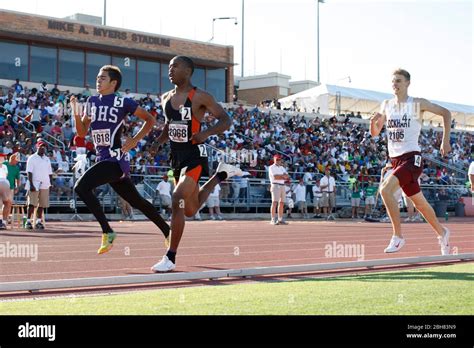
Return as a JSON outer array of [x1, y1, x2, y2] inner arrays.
[[48, 20, 171, 47]]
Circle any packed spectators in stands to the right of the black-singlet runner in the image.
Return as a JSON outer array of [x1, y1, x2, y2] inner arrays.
[[210, 106, 474, 183]]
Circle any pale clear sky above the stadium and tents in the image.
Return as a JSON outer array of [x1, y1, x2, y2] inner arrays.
[[0, 0, 474, 105]]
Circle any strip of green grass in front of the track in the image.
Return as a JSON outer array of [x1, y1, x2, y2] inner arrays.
[[0, 263, 474, 315]]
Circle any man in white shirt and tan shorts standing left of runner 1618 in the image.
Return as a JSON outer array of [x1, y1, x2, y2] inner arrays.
[[25, 140, 53, 230]]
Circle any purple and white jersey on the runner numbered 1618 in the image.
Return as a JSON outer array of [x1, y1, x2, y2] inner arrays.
[[85, 94, 138, 175]]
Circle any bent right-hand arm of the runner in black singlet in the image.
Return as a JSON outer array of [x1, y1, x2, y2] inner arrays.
[[192, 91, 232, 144]]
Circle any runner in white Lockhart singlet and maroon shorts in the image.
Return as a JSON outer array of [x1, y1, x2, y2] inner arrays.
[[370, 69, 451, 255]]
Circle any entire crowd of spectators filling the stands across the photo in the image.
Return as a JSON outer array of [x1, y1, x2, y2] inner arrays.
[[0, 80, 474, 204]]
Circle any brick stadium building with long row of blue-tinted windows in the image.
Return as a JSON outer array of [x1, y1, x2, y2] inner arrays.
[[0, 10, 234, 102]]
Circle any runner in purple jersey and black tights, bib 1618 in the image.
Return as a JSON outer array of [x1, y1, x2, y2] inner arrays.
[[71, 65, 170, 254]]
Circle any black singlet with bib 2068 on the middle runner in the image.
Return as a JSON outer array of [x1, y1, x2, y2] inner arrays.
[[164, 87, 201, 151]]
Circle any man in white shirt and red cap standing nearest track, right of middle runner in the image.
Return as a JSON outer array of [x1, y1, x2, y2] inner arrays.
[[268, 154, 290, 225]]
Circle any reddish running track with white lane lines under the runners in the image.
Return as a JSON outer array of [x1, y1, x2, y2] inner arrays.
[[0, 218, 474, 282]]
